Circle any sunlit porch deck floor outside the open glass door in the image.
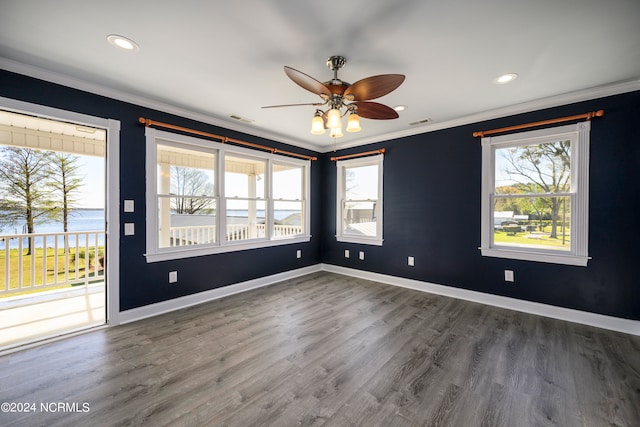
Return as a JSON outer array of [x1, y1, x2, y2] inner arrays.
[[0, 283, 106, 352]]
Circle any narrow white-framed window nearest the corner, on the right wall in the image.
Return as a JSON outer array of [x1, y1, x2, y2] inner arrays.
[[336, 154, 383, 246]]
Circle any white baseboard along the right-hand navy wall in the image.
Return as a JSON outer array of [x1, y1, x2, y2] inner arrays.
[[322, 264, 640, 335]]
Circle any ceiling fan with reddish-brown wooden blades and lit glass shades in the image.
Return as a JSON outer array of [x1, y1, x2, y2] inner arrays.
[[262, 56, 405, 138]]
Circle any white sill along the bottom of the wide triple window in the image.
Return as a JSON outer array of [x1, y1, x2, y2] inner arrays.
[[145, 236, 311, 263]]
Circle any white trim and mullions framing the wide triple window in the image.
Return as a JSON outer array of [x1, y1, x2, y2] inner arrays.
[[145, 127, 311, 262]]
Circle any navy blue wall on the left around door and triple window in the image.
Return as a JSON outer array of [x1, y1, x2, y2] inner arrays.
[[0, 70, 322, 310]]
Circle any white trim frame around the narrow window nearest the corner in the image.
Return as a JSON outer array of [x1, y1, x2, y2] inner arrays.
[[336, 154, 384, 246]]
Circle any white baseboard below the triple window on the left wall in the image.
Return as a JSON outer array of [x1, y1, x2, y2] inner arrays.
[[118, 264, 322, 324]]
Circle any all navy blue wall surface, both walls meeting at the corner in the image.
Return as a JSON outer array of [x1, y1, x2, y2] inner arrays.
[[0, 71, 640, 320]]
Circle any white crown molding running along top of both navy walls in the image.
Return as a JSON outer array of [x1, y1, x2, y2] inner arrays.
[[0, 57, 640, 153]]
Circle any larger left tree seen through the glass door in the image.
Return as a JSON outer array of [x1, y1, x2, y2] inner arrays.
[[0, 147, 56, 255]]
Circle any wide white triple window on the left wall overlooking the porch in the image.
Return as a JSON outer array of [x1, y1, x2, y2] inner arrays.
[[146, 128, 310, 262]]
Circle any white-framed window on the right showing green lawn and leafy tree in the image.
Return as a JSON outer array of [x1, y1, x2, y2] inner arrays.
[[480, 122, 590, 266]]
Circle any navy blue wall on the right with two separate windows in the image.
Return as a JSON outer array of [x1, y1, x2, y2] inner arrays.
[[321, 92, 640, 320]]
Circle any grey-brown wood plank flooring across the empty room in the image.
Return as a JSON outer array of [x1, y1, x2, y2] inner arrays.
[[0, 272, 640, 427]]
